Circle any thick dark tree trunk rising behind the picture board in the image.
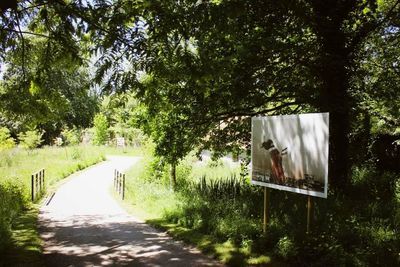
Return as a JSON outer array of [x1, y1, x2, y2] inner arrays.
[[314, 1, 352, 195]]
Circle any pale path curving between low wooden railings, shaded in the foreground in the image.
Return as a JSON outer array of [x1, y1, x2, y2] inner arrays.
[[39, 157, 220, 267]]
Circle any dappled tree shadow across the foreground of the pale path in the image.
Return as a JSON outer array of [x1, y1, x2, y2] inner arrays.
[[40, 215, 218, 266]]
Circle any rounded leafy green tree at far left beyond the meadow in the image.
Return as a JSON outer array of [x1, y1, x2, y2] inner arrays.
[[0, 38, 98, 143]]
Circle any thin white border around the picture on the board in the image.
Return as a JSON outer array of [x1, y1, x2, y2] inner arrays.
[[250, 113, 329, 198]]
